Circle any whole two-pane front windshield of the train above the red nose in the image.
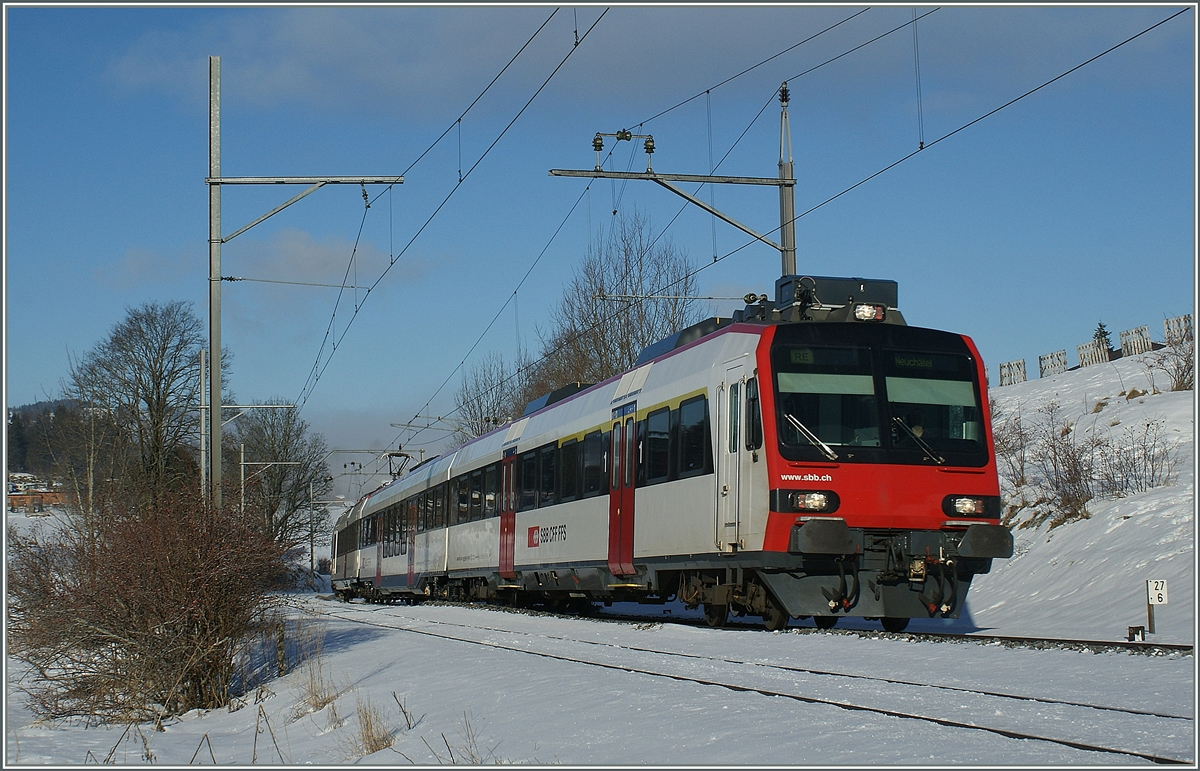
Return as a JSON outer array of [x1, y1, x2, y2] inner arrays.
[[772, 326, 988, 466]]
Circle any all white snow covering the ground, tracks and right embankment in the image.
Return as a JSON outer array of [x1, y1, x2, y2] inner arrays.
[[5, 350, 1196, 765]]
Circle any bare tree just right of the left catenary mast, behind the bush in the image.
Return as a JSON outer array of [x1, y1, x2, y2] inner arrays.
[[229, 400, 332, 546]]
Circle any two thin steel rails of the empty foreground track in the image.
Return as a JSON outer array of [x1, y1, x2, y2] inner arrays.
[[318, 605, 1193, 765]]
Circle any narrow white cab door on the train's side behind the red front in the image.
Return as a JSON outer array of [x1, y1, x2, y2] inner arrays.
[[716, 360, 745, 552]]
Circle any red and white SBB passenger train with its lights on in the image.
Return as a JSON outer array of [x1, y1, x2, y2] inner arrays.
[[331, 276, 1013, 632]]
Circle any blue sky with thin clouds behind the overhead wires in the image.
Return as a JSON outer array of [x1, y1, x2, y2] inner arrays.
[[5, 5, 1196, 494]]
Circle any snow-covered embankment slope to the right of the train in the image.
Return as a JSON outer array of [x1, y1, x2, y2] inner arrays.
[[967, 355, 1195, 644]]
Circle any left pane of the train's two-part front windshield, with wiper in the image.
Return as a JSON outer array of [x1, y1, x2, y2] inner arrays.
[[773, 346, 880, 451]]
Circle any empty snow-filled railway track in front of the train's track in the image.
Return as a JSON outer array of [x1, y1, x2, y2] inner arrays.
[[318, 595, 1194, 764]]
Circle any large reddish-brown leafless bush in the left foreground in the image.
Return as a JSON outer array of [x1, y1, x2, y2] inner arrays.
[[7, 492, 286, 721]]
